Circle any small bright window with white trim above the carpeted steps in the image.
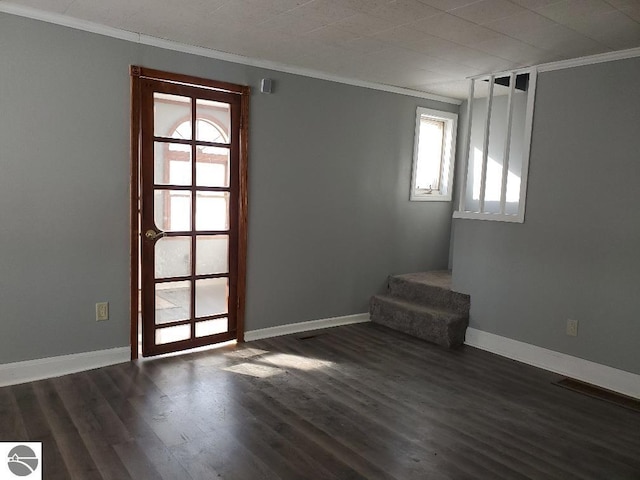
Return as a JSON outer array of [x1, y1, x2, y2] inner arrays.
[[410, 107, 458, 201]]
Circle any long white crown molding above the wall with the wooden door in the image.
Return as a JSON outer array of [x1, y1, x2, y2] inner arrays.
[[0, 1, 462, 105]]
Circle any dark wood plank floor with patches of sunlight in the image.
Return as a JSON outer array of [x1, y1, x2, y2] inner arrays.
[[0, 324, 640, 480]]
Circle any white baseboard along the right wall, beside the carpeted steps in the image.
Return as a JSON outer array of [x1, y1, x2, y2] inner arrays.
[[464, 327, 640, 399]]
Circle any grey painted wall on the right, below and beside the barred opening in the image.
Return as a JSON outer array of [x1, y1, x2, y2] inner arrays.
[[452, 58, 640, 373]]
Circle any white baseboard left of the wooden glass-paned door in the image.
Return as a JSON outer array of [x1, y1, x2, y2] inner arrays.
[[0, 347, 131, 387]]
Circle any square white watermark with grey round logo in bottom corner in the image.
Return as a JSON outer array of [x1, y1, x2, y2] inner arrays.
[[0, 442, 42, 480]]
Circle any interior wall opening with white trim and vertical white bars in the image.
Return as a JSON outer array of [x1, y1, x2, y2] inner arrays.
[[453, 69, 536, 223]]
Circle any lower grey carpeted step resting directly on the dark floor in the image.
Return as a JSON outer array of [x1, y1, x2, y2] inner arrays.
[[369, 295, 469, 348]]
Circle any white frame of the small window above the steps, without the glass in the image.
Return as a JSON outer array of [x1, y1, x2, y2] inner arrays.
[[409, 107, 458, 202]]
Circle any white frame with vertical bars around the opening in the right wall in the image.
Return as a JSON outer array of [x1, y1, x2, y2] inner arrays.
[[453, 68, 538, 223]]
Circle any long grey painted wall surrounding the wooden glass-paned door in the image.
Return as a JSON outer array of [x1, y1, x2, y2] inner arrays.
[[0, 14, 457, 363]]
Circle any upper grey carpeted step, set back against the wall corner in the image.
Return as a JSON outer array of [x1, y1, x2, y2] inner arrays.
[[387, 270, 471, 316]]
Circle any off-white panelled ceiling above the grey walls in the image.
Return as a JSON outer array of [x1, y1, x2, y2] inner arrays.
[[0, 0, 640, 98]]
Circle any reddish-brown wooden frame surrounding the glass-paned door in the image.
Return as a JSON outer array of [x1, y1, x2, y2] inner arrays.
[[129, 65, 251, 360]]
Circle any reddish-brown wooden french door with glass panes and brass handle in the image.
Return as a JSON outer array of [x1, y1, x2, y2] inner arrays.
[[132, 67, 248, 356]]
